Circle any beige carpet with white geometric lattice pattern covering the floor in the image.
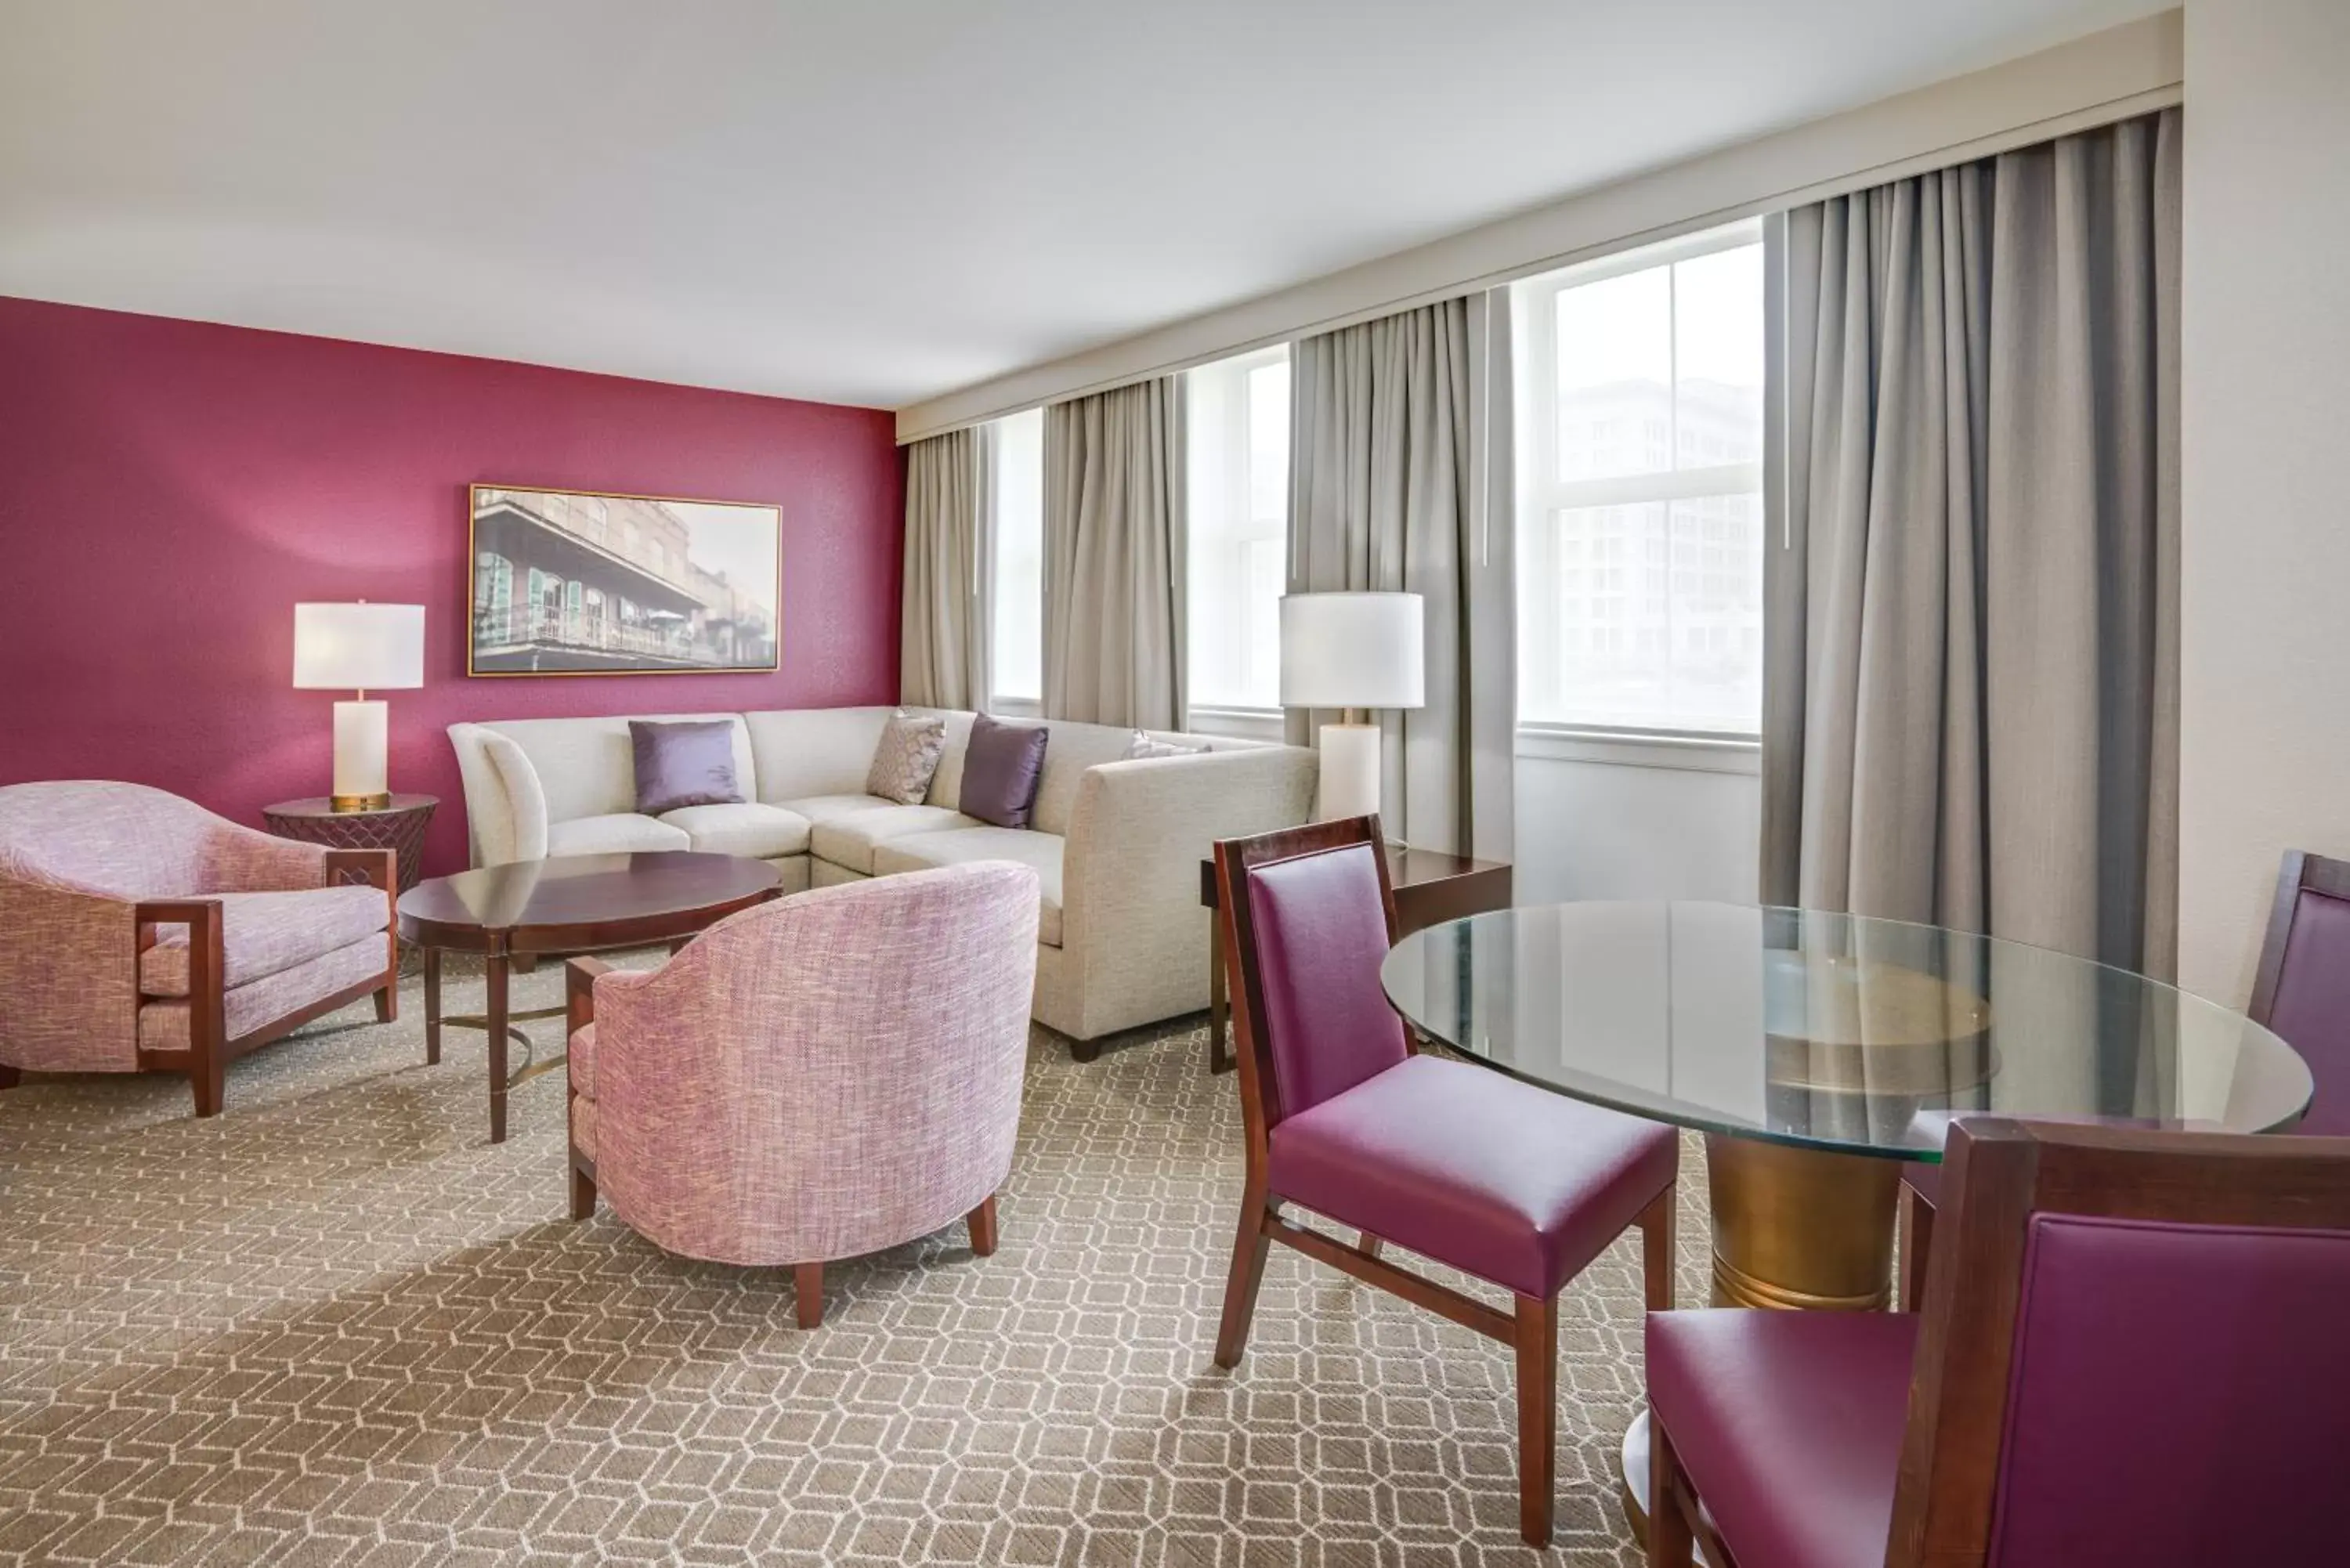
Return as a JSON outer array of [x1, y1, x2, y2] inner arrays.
[[0, 957, 1704, 1568]]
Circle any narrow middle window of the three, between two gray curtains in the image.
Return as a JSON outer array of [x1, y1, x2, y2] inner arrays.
[[1184, 345, 1290, 710]]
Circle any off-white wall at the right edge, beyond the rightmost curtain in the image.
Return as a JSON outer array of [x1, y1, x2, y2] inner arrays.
[[2178, 0, 2350, 1004]]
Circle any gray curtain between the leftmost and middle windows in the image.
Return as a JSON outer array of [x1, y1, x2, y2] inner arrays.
[[1043, 376, 1187, 728]]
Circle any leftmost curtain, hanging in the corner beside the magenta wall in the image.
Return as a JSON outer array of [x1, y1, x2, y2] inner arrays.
[[898, 425, 994, 712]]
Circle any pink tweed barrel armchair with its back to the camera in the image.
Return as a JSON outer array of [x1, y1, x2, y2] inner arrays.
[[569, 861, 1036, 1328]]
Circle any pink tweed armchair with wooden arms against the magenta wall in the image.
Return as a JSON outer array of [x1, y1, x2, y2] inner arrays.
[[0, 780, 400, 1117]]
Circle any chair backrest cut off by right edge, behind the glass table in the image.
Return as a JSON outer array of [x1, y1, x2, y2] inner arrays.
[[2249, 849, 2350, 1138]]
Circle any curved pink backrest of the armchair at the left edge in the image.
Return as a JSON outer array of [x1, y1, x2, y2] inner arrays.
[[0, 778, 240, 898]]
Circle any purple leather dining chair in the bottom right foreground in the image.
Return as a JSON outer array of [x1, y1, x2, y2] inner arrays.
[[1647, 1117, 2350, 1568]]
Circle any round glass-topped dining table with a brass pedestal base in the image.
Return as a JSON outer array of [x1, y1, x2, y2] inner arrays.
[[1379, 903, 2310, 1516]]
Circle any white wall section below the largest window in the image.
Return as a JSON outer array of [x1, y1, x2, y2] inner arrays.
[[1513, 733, 1762, 903]]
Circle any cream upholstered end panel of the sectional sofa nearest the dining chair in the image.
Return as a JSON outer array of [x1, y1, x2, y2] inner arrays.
[[1062, 745, 1316, 1039]]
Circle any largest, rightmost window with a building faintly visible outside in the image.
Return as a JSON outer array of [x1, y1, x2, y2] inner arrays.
[[1511, 223, 1765, 735]]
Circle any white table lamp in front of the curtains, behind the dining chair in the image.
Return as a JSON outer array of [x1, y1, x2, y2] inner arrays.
[[1281, 592, 1426, 823]]
